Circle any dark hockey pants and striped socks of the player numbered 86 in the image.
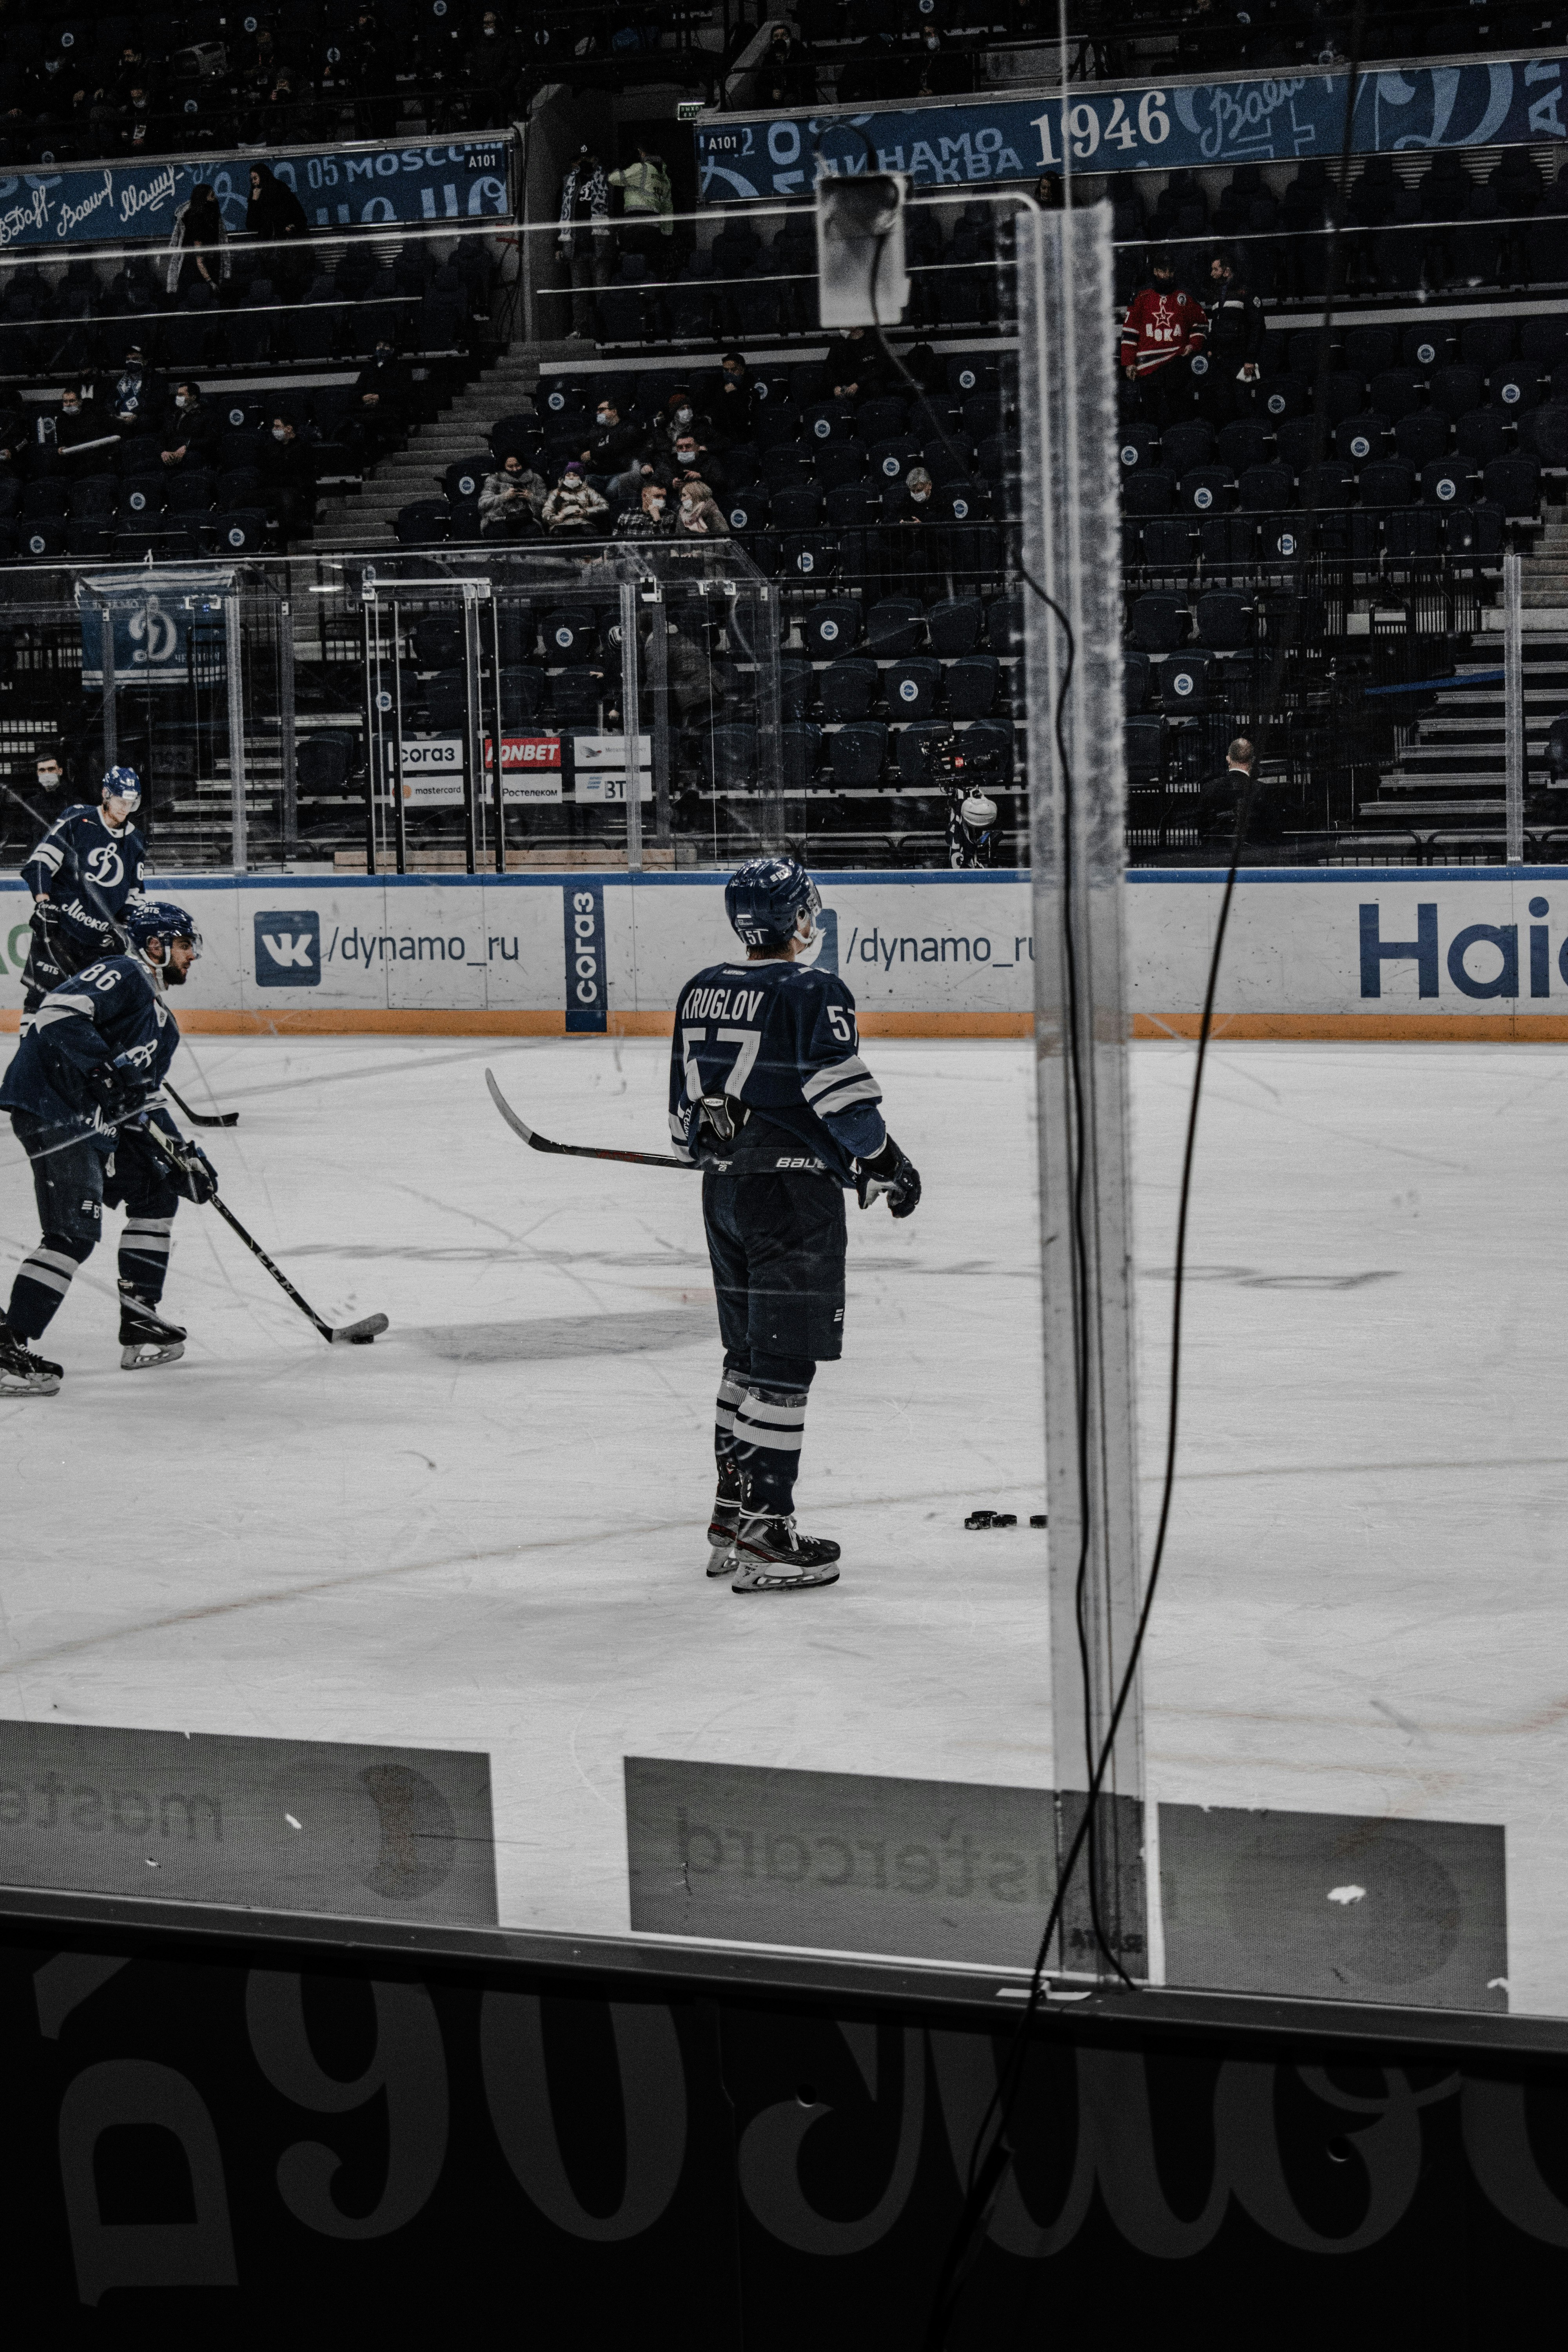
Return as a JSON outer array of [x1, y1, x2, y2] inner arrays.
[[7, 1110, 179, 1341]]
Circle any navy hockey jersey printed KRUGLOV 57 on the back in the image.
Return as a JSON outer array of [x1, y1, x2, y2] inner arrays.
[[670, 960, 886, 1185]]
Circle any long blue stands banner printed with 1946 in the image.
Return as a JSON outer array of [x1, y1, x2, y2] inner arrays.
[[696, 56, 1568, 205]]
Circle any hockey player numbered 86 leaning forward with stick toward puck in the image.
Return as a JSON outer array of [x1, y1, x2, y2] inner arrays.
[[0, 898, 216, 1397]]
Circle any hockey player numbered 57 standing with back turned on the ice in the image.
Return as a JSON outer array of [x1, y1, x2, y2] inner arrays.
[[670, 858, 919, 1592]]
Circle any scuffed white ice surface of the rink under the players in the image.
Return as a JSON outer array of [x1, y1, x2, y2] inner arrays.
[[0, 1037, 1568, 2011]]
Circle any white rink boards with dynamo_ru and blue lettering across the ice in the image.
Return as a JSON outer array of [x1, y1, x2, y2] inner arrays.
[[0, 866, 1568, 1040]]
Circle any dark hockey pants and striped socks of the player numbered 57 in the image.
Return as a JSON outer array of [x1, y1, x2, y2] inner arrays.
[[703, 1176, 846, 1517]]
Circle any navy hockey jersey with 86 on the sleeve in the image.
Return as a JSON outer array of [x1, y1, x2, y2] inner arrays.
[[0, 955, 179, 1152]]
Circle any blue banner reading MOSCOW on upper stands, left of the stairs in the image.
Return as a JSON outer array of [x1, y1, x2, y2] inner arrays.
[[0, 134, 512, 249]]
